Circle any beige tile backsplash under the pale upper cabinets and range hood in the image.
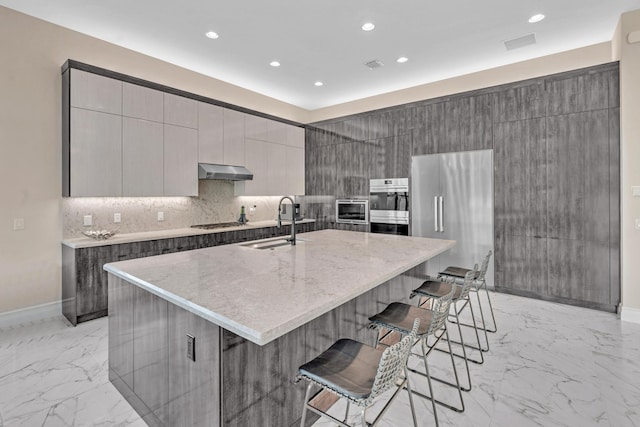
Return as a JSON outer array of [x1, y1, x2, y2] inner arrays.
[[62, 180, 288, 239]]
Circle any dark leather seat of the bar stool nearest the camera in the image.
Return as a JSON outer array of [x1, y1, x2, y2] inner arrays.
[[300, 339, 383, 399]]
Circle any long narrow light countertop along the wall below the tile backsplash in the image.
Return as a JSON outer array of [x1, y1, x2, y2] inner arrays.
[[62, 219, 315, 249]]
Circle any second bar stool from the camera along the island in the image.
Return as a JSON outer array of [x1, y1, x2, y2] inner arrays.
[[369, 286, 464, 426]]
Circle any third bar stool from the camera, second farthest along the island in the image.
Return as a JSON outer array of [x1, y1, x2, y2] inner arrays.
[[409, 270, 484, 391]]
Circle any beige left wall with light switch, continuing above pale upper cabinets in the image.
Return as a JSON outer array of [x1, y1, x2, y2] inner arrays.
[[0, 7, 307, 313]]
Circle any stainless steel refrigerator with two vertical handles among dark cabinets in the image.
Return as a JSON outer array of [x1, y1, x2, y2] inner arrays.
[[410, 150, 494, 287]]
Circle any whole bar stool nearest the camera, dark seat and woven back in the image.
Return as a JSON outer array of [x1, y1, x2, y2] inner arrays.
[[295, 319, 420, 427]]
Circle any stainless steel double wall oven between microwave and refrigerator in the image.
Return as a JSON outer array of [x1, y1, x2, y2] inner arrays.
[[369, 178, 409, 236]]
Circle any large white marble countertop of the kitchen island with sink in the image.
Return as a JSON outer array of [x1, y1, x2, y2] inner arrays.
[[104, 230, 455, 345]]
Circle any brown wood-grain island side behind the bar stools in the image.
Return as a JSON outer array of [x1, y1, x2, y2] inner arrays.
[[222, 264, 426, 426]]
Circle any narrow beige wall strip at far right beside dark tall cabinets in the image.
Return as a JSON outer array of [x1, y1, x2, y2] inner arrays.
[[618, 10, 640, 321]]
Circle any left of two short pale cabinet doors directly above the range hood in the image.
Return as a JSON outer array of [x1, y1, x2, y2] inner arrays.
[[198, 102, 224, 164]]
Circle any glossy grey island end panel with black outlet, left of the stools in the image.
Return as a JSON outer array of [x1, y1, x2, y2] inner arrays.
[[109, 274, 221, 427]]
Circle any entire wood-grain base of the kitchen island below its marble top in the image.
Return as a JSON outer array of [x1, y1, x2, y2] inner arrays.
[[109, 265, 426, 427]]
